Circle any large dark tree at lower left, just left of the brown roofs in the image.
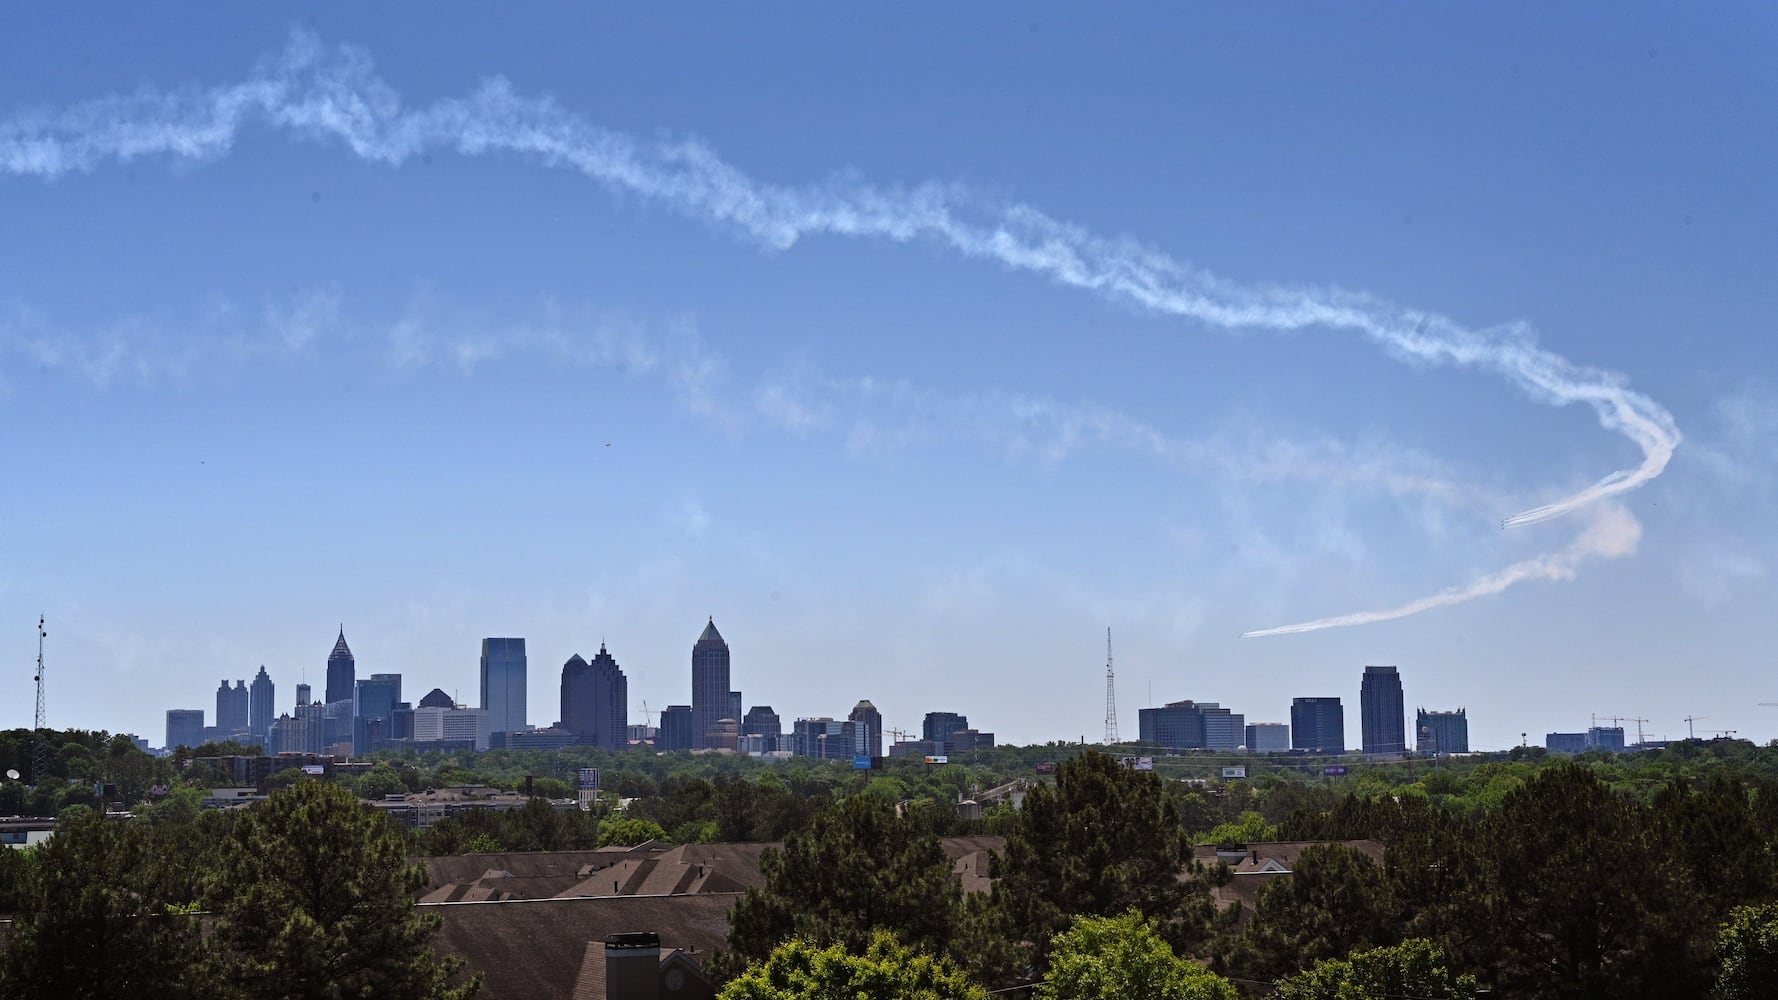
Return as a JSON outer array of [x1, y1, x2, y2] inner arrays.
[[208, 781, 480, 1000]]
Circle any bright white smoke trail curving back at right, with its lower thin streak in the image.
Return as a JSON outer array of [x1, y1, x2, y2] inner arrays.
[[0, 32, 1680, 630]]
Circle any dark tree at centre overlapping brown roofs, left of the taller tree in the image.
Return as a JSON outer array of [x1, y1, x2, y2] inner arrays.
[[729, 795, 962, 961]]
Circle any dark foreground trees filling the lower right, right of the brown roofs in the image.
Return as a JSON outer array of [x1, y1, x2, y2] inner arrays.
[[696, 753, 1778, 1000]]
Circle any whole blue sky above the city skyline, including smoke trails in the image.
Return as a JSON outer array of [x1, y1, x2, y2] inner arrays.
[[0, 5, 1778, 747]]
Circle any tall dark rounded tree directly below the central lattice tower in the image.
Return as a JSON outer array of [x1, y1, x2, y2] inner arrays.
[[992, 751, 1213, 970]]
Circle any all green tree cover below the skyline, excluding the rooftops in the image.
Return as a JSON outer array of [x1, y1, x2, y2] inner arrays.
[[10, 731, 1778, 998]]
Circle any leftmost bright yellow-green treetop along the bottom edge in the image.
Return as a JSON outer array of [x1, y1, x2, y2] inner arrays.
[[717, 932, 987, 1000]]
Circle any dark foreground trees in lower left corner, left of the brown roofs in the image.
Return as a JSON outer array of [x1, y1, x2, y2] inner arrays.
[[0, 781, 478, 1000]]
